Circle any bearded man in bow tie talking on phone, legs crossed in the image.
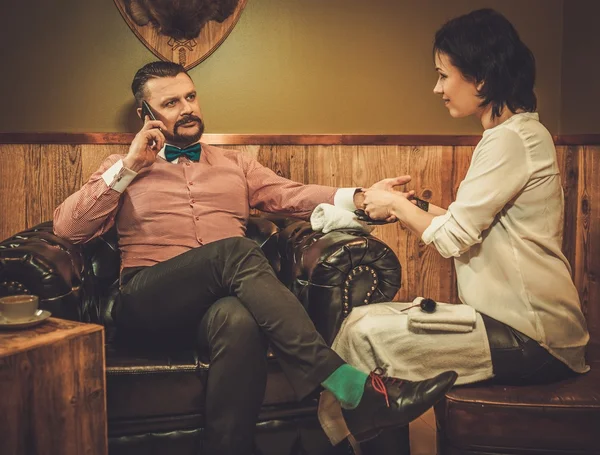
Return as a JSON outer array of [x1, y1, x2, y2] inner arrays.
[[54, 62, 456, 455]]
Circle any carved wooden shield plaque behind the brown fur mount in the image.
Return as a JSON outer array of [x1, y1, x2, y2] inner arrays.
[[114, 0, 247, 70]]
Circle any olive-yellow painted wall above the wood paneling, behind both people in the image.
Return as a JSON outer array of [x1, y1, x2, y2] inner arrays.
[[0, 0, 600, 134]]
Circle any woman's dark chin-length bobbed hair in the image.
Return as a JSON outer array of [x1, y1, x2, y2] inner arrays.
[[433, 9, 537, 118]]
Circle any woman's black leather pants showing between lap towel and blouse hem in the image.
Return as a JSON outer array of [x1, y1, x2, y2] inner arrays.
[[481, 314, 576, 385]]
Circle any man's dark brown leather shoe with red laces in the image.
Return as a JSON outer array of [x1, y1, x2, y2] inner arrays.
[[342, 368, 458, 441]]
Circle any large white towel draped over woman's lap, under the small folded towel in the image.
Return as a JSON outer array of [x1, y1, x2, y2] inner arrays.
[[332, 302, 493, 384]]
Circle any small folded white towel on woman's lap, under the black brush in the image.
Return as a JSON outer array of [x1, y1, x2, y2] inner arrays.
[[408, 297, 477, 333]]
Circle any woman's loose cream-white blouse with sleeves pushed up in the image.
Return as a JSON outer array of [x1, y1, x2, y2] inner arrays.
[[422, 113, 589, 372]]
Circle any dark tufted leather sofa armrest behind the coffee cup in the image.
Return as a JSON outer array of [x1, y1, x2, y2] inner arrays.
[[0, 222, 85, 320]]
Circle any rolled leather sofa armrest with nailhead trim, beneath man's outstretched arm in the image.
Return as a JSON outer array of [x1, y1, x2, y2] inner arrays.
[[279, 219, 401, 344]]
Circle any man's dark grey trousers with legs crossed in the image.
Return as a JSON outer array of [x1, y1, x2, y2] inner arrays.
[[115, 237, 343, 455]]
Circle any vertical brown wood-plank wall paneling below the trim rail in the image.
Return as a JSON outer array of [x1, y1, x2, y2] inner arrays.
[[0, 144, 600, 330]]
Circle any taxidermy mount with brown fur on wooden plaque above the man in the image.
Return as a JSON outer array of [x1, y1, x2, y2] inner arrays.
[[114, 0, 247, 69]]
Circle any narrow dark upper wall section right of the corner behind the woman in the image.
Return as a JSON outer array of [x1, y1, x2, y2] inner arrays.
[[559, 0, 600, 134]]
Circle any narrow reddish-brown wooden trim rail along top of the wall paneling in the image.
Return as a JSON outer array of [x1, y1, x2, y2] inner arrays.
[[0, 132, 600, 146]]
